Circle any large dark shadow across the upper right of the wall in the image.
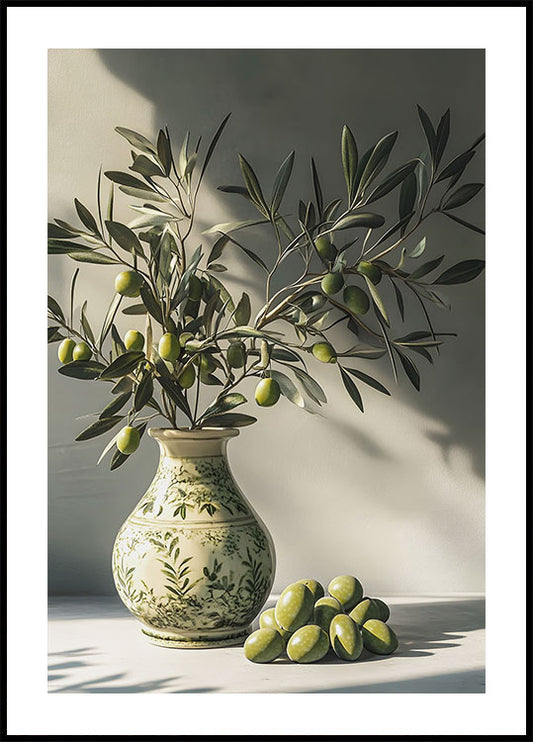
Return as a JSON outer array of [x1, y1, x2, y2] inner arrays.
[[99, 49, 484, 477]]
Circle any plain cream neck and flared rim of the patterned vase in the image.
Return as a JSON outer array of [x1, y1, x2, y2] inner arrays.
[[148, 428, 239, 459]]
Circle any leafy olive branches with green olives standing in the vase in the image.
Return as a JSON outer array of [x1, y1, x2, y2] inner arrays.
[[48, 106, 484, 469]]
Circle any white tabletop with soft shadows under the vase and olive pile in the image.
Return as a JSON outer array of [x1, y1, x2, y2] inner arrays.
[[48, 594, 485, 693]]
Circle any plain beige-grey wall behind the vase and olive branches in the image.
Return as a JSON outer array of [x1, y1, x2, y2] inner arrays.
[[49, 50, 484, 594]]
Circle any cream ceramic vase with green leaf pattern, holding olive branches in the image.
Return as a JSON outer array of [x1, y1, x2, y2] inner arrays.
[[113, 428, 275, 648]]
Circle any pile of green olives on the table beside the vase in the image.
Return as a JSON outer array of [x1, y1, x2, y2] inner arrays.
[[244, 575, 398, 664]]
